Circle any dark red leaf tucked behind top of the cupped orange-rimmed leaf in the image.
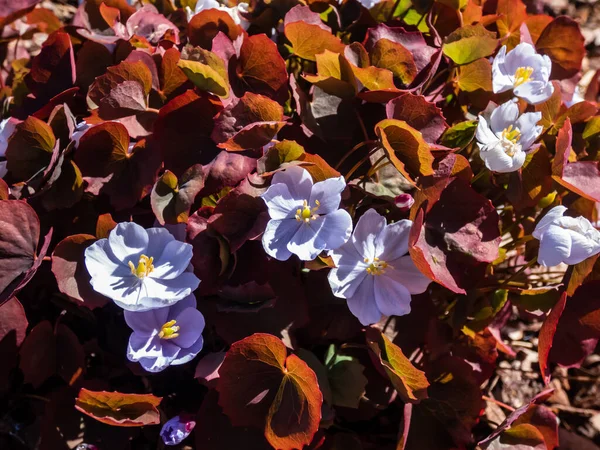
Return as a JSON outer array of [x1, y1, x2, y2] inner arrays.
[[386, 92, 448, 144]]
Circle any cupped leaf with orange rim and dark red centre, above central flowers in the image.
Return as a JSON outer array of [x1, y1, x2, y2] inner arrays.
[[375, 119, 434, 184]]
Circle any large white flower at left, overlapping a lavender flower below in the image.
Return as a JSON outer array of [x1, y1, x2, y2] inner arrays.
[[85, 222, 200, 311]]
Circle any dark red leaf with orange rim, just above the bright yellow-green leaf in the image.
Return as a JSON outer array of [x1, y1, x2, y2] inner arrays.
[[187, 8, 242, 49]]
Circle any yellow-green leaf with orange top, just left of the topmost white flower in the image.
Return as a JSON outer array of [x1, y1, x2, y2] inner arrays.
[[442, 24, 498, 65]]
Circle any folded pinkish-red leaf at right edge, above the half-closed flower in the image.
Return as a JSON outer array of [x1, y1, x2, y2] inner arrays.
[[552, 119, 600, 202]]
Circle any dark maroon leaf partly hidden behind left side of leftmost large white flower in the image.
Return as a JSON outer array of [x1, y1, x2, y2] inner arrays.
[[52, 234, 108, 309]]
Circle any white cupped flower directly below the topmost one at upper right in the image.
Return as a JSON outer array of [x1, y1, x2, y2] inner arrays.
[[475, 101, 543, 173]]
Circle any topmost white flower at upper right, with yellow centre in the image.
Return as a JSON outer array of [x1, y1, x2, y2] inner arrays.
[[492, 42, 554, 105]]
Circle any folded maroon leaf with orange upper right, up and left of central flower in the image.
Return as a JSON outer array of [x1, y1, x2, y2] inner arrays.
[[211, 92, 285, 151]]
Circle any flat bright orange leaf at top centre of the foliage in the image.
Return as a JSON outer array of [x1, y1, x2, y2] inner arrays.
[[285, 22, 344, 61]]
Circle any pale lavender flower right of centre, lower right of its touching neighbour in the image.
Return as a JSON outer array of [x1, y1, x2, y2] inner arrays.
[[329, 209, 431, 325]]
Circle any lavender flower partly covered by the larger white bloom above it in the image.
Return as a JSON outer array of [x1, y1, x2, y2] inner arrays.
[[125, 295, 204, 372]]
